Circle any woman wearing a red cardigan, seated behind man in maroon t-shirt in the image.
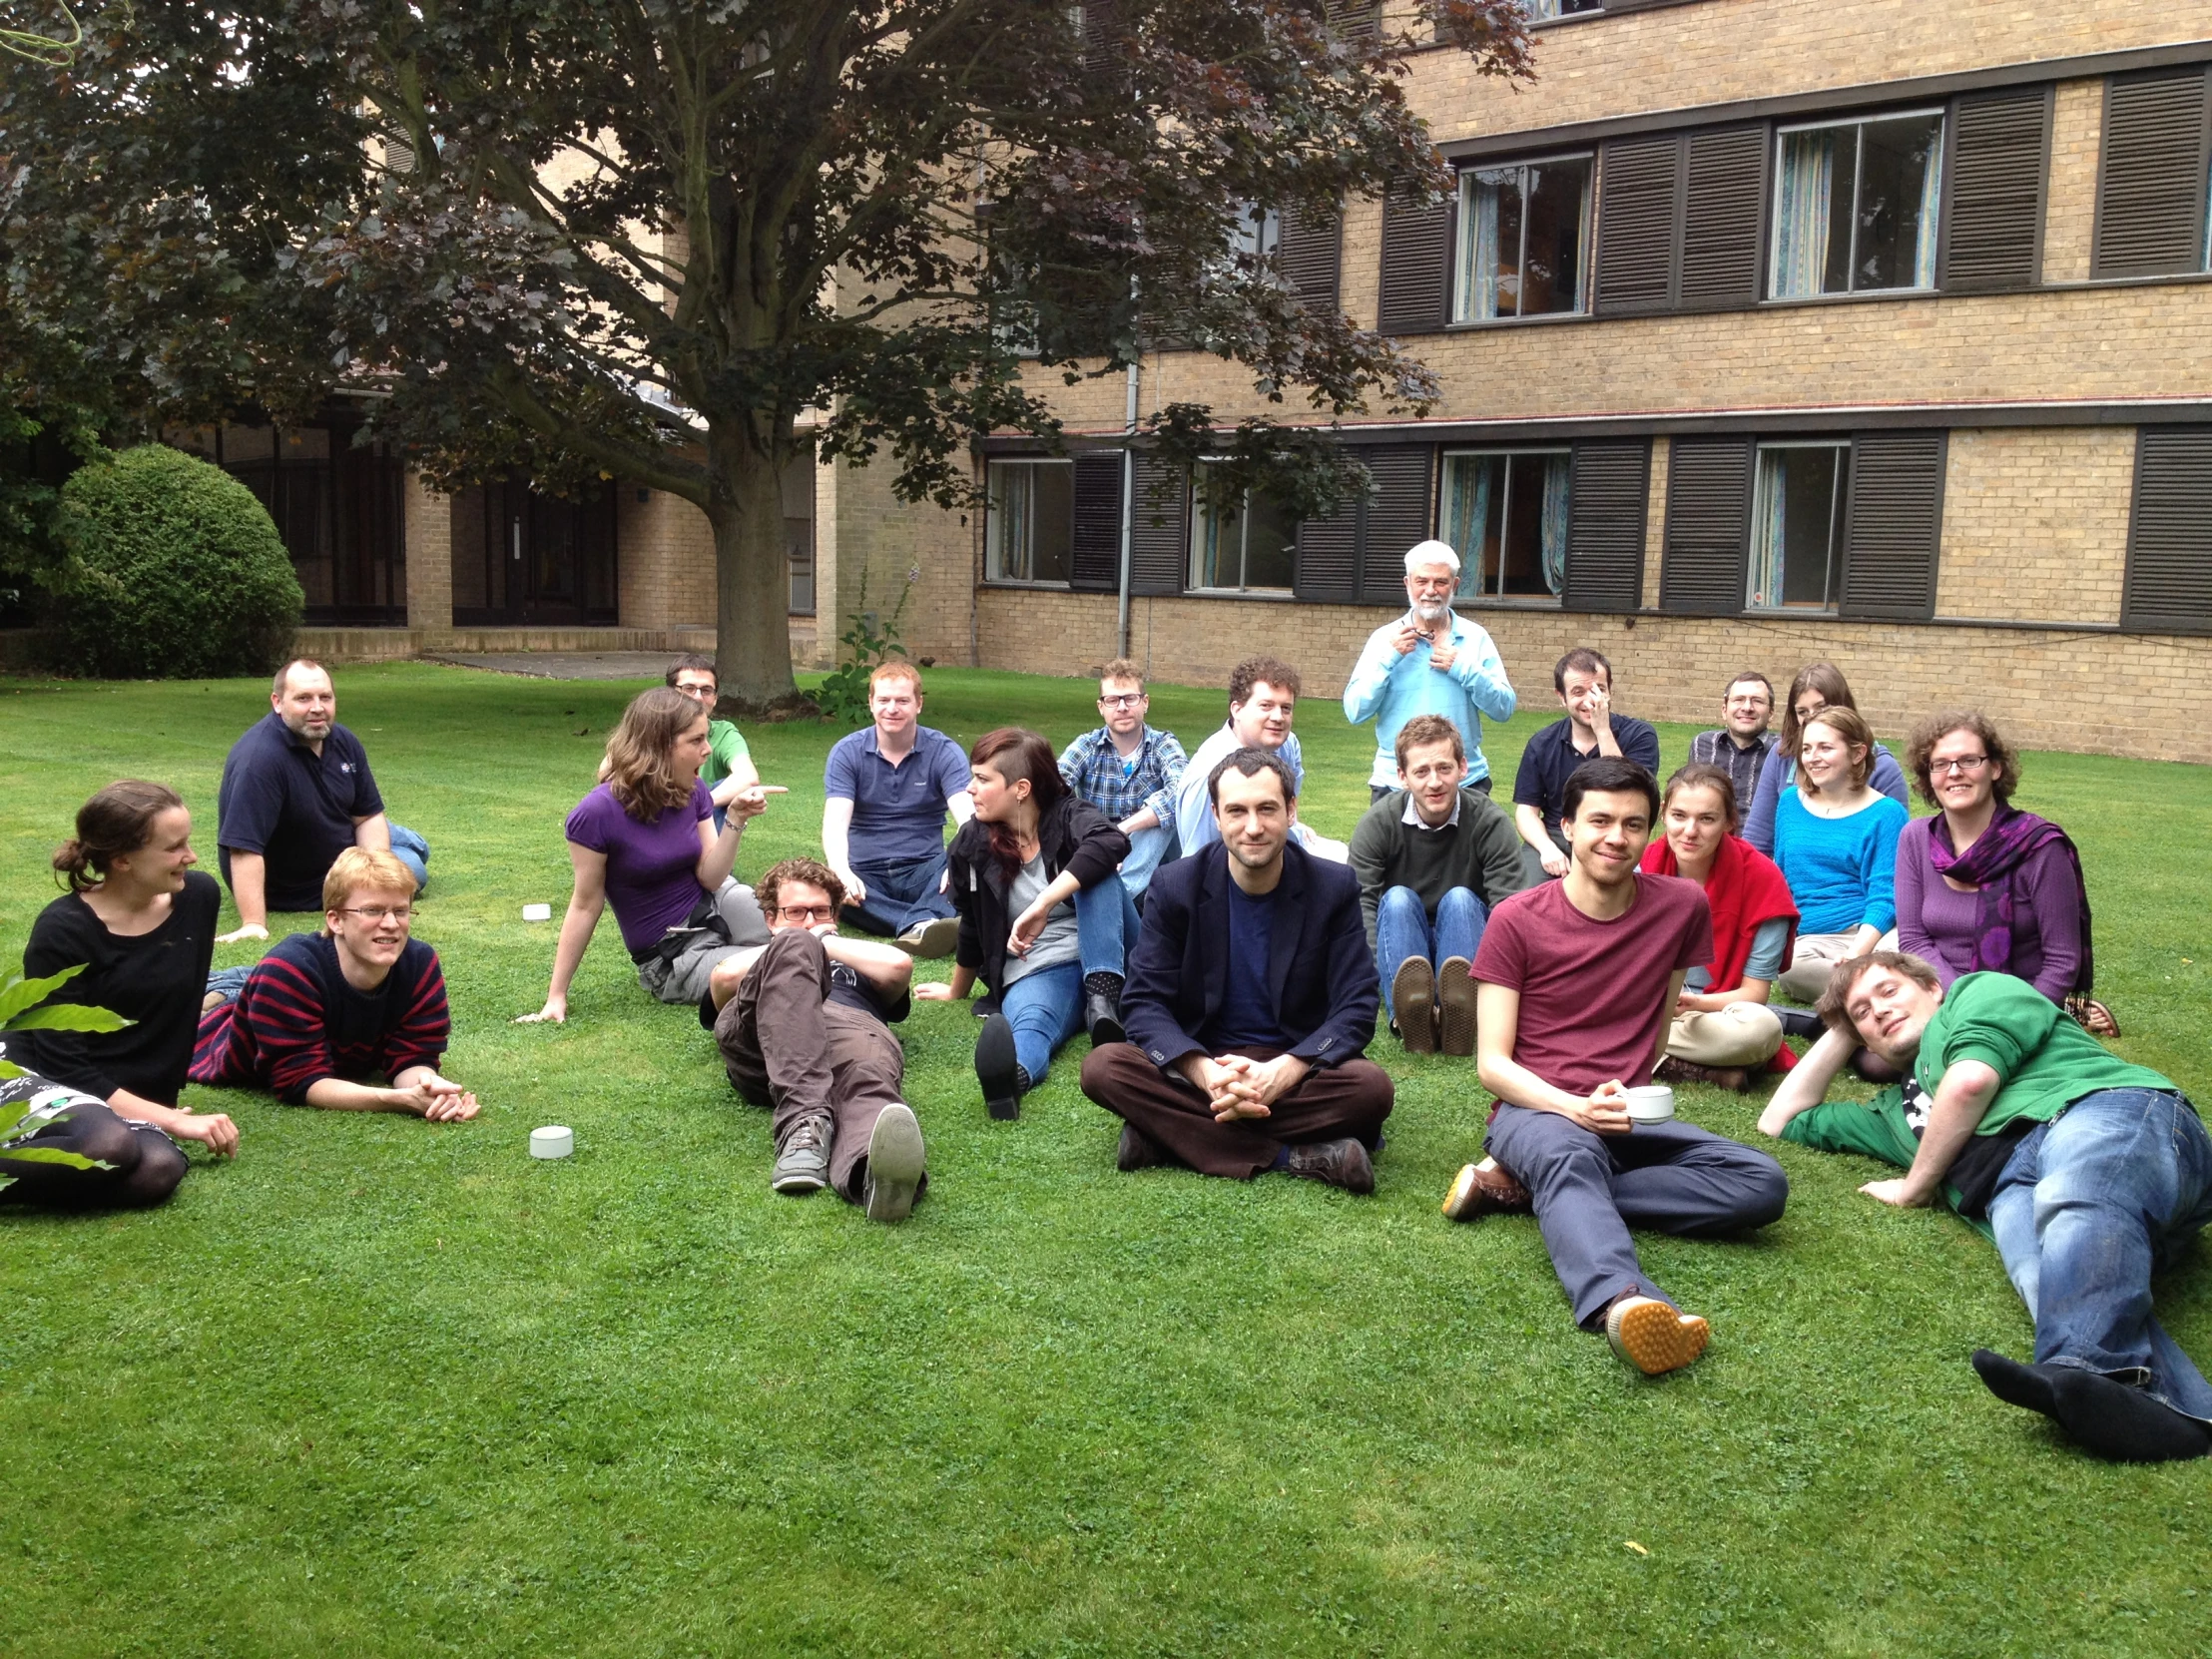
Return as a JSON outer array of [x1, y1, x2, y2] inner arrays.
[[1643, 766, 1796, 1088]]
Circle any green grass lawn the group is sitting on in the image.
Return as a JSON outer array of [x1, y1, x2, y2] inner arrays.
[[0, 668, 2212, 1659]]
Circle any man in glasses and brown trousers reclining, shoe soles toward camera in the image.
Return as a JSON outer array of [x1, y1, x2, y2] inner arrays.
[[699, 858, 929, 1221]]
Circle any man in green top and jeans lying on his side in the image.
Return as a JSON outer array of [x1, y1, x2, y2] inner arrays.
[[1759, 951, 2212, 1462]]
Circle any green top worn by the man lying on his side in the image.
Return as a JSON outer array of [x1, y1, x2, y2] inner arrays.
[[1783, 973, 2174, 1230]]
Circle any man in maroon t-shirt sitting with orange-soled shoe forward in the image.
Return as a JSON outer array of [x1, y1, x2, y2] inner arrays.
[[1444, 757, 1790, 1376]]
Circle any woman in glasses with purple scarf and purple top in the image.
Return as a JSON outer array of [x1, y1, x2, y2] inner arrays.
[[1898, 713, 2119, 1037]]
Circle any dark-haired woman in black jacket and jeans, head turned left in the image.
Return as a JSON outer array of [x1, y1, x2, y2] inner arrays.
[[913, 726, 1137, 1117]]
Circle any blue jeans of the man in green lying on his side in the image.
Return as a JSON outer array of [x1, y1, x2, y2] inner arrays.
[[1988, 1088, 2212, 1422]]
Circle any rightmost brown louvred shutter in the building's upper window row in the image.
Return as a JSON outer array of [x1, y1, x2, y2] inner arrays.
[[2090, 64, 2208, 276]]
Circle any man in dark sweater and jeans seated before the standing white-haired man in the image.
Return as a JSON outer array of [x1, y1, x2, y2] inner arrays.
[[1352, 715, 1524, 1055]]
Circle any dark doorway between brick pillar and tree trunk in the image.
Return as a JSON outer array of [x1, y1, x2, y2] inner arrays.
[[453, 478, 617, 628]]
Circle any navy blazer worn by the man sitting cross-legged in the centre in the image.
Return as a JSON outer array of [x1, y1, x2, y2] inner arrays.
[[1122, 840, 1382, 1071]]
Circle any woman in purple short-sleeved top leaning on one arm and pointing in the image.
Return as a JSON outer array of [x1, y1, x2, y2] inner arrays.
[[522, 686, 783, 1022]]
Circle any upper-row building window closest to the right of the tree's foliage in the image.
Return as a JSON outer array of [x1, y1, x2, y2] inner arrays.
[[1451, 155, 1590, 323]]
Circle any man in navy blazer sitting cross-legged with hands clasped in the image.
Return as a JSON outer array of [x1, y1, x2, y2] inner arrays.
[[1084, 748, 1391, 1192]]
